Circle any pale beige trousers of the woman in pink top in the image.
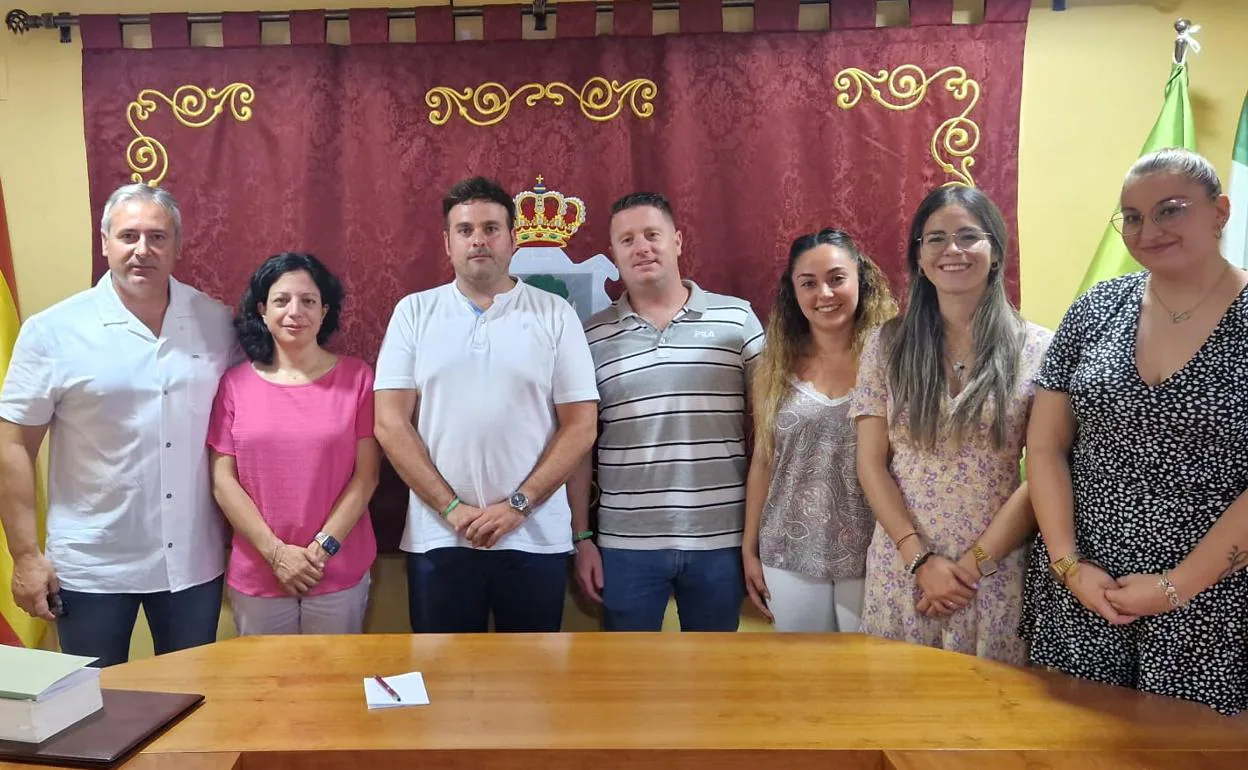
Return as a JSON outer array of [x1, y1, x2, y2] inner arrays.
[[230, 574, 372, 636]]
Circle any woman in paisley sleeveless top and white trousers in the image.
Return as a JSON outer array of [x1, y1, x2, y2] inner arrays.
[[741, 230, 897, 631]]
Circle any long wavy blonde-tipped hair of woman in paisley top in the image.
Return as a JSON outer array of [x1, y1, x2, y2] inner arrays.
[[753, 228, 897, 456]]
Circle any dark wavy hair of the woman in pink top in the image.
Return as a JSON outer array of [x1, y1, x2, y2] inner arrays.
[[235, 251, 347, 364]]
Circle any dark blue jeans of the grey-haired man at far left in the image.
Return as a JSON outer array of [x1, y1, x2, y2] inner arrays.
[[56, 577, 225, 668]]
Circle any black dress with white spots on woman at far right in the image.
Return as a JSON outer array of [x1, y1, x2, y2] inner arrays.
[[1020, 273, 1248, 714]]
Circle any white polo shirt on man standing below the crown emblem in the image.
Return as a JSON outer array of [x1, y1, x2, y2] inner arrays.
[[374, 281, 598, 553]]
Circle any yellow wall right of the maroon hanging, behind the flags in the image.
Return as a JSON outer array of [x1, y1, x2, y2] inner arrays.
[[1018, 0, 1248, 327]]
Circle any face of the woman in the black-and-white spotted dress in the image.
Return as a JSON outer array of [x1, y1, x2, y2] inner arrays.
[[1114, 171, 1231, 275]]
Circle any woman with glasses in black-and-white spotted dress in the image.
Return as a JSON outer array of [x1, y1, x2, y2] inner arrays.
[[1021, 150, 1248, 714]]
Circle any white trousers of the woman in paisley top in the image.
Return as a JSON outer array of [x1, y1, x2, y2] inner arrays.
[[763, 564, 866, 633]]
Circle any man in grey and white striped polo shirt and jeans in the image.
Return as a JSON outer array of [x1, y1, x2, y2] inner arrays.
[[568, 192, 763, 631]]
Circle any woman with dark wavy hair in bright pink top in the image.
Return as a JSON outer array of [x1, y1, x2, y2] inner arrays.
[[208, 253, 381, 635]]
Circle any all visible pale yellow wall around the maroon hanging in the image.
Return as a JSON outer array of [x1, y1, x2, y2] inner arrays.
[[0, 0, 1248, 650]]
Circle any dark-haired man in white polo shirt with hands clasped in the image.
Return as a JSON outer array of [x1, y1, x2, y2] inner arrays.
[[374, 177, 598, 633]]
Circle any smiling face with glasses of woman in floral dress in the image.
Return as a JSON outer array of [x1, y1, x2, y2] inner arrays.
[[919, 203, 995, 300]]
